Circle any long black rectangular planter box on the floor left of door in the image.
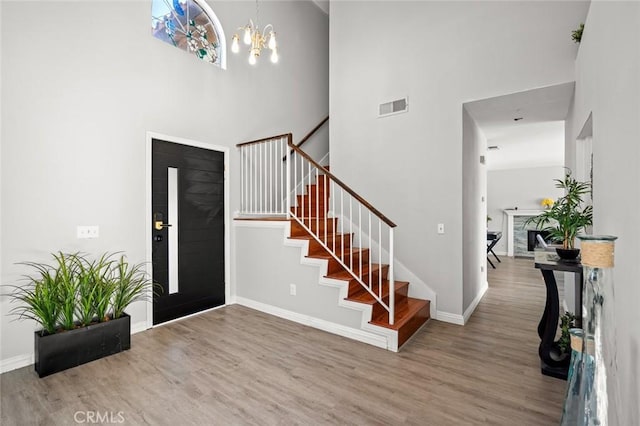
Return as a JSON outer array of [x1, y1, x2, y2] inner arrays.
[[35, 314, 131, 377]]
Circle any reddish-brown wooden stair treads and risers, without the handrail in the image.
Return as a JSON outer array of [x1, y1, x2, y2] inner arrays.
[[289, 167, 430, 348]]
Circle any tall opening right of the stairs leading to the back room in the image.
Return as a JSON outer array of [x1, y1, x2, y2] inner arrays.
[[462, 82, 575, 311]]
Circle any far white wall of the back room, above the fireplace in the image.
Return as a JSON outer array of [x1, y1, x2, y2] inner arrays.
[[487, 166, 565, 253]]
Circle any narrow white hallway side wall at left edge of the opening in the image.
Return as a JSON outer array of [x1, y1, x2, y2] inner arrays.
[[462, 108, 487, 312]]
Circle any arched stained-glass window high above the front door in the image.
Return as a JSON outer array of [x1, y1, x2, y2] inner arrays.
[[151, 0, 227, 69]]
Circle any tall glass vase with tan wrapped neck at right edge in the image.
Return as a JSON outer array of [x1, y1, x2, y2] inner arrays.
[[572, 235, 617, 426]]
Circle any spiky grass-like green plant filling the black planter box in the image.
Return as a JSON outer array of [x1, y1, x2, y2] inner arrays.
[[8, 252, 153, 335]]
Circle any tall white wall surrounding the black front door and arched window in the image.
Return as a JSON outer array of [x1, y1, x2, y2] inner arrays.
[[0, 1, 328, 365]]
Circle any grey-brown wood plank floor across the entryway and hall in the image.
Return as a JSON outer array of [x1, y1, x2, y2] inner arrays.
[[0, 258, 565, 426]]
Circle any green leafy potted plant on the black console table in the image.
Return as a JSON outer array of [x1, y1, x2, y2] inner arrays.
[[525, 170, 593, 249]]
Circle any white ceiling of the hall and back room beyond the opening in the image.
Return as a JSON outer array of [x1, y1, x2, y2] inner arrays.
[[465, 82, 574, 170]]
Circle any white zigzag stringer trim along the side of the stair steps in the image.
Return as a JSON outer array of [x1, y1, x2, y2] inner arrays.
[[283, 221, 398, 352]]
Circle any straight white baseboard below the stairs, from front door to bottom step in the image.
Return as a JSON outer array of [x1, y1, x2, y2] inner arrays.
[[236, 296, 387, 349]]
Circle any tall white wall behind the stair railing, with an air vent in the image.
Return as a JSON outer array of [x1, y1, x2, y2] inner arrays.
[[330, 1, 587, 315]]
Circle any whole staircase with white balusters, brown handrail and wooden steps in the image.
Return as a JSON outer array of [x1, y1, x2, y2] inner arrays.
[[237, 128, 430, 351]]
